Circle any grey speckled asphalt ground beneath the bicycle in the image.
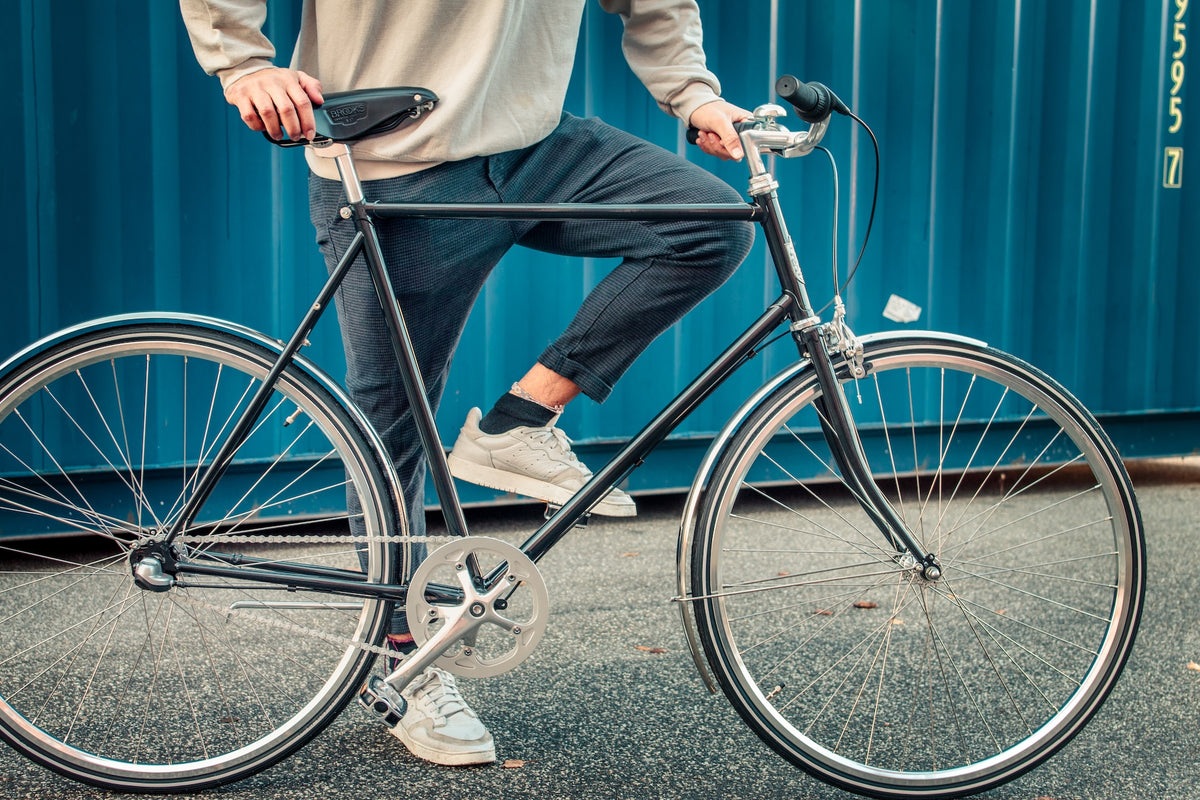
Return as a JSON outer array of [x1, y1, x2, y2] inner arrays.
[[0, 458, 1200, 800]]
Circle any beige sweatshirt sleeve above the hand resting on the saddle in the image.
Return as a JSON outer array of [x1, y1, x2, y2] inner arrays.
[[179, 0, 275, 88]]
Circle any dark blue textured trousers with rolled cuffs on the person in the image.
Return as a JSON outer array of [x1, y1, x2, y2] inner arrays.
[[310, 114, 754, 633]]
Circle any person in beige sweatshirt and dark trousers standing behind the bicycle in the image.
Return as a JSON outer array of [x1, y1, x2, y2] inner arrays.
[[180, 0, 752, 764]]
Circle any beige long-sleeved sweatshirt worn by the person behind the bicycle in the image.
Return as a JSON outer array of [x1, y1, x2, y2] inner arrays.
[[180, 0, 720, 180]]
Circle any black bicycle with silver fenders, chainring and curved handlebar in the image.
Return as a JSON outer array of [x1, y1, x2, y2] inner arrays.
[[0, 77, 1145, 796]]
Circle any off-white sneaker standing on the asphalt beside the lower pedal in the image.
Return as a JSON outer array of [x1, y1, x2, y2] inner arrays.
[[391, 667, 496, 766]]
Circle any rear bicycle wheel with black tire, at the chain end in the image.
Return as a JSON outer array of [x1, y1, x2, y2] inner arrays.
[[0, 321, 407, 792]]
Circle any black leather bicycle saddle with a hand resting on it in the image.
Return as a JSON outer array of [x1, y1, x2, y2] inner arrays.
[[313, 86, 438, 142]]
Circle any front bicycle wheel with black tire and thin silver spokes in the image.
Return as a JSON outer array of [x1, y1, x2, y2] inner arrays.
[[691, 337, 1145, 798]]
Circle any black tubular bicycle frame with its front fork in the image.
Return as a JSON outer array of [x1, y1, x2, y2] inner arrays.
[[166, 193, 931, 602]]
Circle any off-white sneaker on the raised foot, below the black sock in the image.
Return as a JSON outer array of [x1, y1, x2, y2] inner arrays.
[[446, 408, 637, 517]]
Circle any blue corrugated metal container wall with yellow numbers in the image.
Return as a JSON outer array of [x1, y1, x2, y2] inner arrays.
[[0, 0, 1200, 513]]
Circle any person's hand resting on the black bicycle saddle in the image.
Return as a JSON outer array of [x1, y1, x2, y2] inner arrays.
[[226, 67, 325, 139]]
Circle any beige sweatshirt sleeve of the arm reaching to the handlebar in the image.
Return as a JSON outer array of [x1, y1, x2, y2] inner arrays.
[[600, 0, 721, 121]]
